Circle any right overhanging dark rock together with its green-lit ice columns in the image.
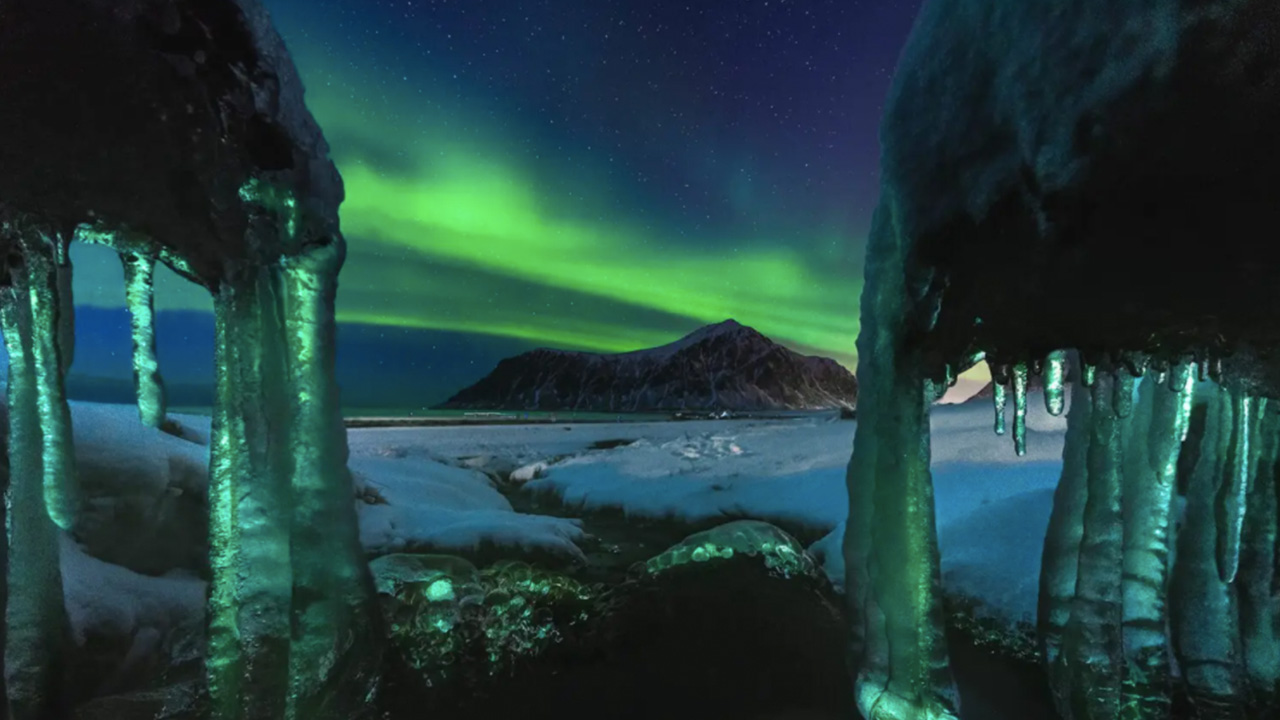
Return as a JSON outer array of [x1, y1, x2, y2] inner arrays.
[[844, 0, 1280, 720]]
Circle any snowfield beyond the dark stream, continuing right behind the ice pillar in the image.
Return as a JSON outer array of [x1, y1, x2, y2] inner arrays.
[[349, 393, 1066, 621]]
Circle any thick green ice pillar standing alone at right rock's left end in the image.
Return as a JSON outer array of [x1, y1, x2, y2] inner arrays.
[[844, 202, 957, 720]]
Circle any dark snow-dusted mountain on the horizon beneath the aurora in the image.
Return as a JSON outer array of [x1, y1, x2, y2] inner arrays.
[[442, 320, 858, 413]]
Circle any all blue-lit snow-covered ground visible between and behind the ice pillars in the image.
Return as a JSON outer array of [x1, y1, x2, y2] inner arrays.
[[52, 396, 1065, 653]]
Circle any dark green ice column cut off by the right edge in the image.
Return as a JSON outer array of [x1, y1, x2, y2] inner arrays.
[[1236, 398, 1280, 707]]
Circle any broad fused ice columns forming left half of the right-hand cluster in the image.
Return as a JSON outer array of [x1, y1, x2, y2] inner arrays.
[[1038, 365, 1192, 720]]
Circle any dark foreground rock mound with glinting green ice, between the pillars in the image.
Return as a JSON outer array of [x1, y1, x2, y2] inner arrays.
[[371, 521, 852, 720]]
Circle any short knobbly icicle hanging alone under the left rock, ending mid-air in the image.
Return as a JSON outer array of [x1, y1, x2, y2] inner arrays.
[[120, 252, 165, 428]]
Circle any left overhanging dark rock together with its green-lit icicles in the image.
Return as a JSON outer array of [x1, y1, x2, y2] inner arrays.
[[0, 0, 380, 720]]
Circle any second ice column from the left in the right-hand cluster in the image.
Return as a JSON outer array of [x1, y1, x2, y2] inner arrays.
[[1062, 373, 1124, 720]]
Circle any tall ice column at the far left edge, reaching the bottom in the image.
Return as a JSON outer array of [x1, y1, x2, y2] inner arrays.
[[0, 275, 67, 720]]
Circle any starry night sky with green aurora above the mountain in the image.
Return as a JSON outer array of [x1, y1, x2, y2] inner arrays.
[[64, 0, 920, 402]]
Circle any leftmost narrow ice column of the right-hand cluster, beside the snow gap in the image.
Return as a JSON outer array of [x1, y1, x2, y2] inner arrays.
[[1036, 368, 1093, 719]]
